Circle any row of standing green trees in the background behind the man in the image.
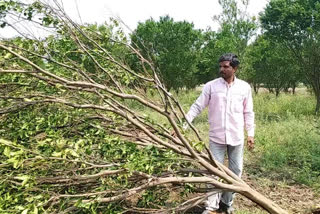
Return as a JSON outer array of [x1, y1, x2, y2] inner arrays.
[[131, 0, 320, 111]]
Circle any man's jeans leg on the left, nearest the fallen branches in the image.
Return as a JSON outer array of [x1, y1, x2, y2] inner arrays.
[[205, 142, 227, 211]]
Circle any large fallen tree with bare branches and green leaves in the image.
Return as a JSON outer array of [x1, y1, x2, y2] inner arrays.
[[0, 1, 287, 214]]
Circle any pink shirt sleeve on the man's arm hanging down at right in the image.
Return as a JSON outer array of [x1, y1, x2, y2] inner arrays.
[[243, 86, 255, 137]]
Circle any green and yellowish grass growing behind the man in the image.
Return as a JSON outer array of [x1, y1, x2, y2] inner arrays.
[[177, 90, 320, 190]]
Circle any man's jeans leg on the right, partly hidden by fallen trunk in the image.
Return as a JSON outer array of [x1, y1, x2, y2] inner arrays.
[[221, 144, 243, 207]]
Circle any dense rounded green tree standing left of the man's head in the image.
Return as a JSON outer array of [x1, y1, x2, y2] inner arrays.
[[131, 16, 201, 90]]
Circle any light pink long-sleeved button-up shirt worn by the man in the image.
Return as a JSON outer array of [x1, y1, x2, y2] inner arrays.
[[186, 77, 255, 146]]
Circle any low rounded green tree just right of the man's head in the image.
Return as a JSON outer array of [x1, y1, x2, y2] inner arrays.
[[242, 35, 302, 96]]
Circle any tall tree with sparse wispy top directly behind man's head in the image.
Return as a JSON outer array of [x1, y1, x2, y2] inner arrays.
[[198, 0, 257, 83]]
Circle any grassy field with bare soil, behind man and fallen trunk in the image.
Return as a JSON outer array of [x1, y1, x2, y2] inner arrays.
[[178, 88, 320, 214]]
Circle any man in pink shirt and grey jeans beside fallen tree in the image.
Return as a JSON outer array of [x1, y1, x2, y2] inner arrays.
[[186, 53, 254, 214]]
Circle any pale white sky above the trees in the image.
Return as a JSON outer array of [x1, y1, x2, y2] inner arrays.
[[0, 0, 268, 37]]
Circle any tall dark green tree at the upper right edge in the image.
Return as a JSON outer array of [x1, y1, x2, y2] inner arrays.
[[261, 0, 320, 112]]
